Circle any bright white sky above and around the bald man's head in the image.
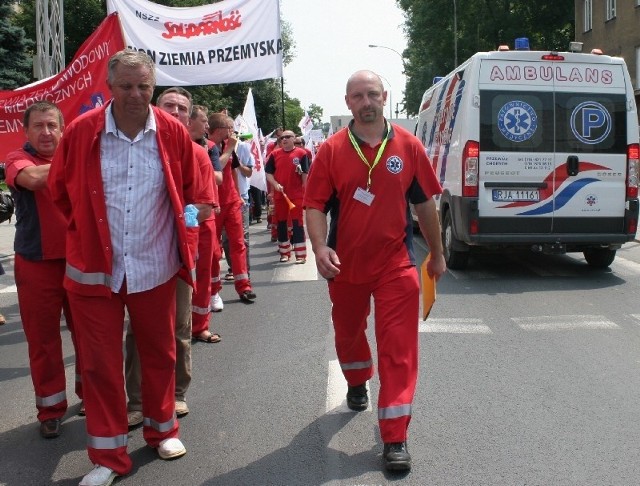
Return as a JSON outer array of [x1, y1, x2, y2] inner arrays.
[[280, 0, 407, 122]]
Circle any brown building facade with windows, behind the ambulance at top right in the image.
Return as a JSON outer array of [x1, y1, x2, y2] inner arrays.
[[574, 0, 640, 106]]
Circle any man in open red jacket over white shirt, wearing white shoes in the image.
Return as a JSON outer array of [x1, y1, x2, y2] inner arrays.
[[49, 50, 200, 486]]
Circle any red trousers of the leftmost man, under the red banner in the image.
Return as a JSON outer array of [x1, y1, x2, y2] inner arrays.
[[14, 254, 82, 422]]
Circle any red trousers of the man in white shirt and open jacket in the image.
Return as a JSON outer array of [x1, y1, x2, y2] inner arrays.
[[69, 277, 179, 475]]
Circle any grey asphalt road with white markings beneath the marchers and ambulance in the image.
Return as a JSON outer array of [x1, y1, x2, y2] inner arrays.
[[0, 223, 640, 486]]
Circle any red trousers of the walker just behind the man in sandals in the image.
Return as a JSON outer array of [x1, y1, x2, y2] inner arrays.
[[211, 201, 251, 295]]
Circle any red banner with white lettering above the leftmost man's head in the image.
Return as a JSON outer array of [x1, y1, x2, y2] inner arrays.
[[0, 14, 124, 162]]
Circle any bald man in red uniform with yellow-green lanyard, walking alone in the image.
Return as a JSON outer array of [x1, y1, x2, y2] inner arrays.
[[304, 71, 446, 471]]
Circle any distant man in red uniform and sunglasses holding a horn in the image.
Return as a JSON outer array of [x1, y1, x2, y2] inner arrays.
[[264, 130, 309, 264]]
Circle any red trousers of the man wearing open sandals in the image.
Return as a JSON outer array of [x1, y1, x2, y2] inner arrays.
[[191, 217, 220, 337]]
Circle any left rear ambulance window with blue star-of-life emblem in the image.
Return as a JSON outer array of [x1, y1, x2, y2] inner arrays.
[[480, 90, 554, 152]]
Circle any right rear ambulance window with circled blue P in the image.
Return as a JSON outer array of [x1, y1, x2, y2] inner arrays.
[[556, 93, 627, 154]]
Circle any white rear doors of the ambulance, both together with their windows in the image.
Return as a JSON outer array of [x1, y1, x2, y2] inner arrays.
[[478, 52, 628, 237]]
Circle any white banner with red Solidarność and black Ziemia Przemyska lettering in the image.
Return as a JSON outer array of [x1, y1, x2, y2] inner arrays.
[[107, 0, 282, 86]]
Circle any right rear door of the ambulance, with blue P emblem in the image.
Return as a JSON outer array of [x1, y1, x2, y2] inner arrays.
[[552, 59, 635, 234]]
